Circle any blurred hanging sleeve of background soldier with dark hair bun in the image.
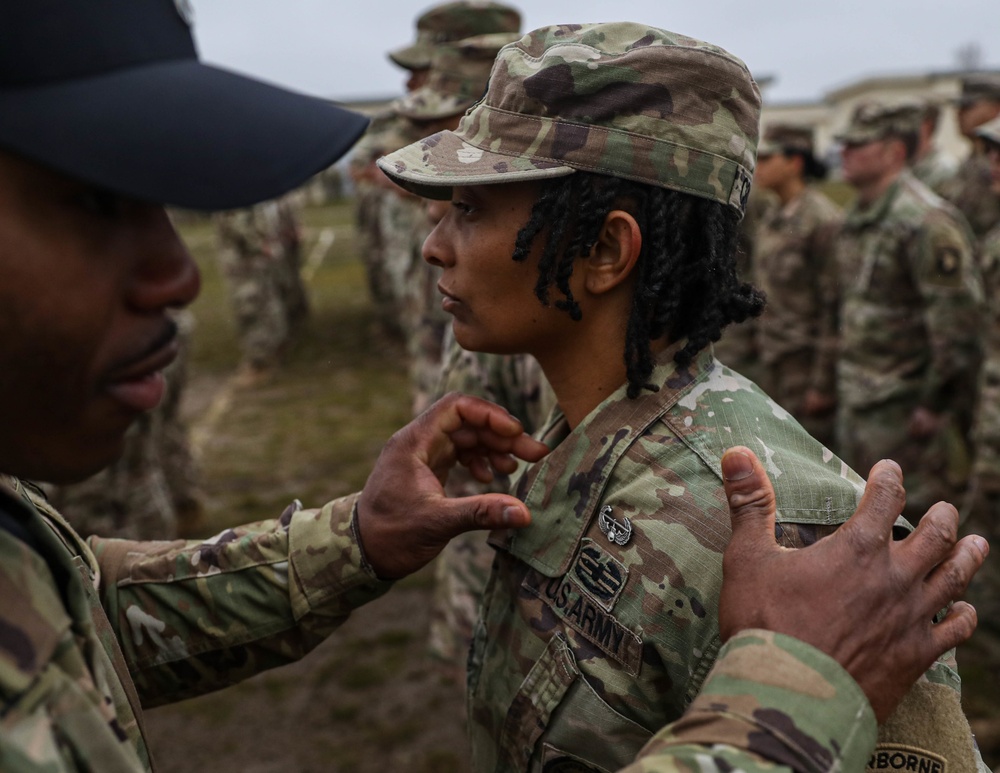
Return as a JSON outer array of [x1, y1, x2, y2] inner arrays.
[[809, 220, 840, 395]]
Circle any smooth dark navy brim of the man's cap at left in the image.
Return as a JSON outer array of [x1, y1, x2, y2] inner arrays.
[[0, 59, 368, 210]]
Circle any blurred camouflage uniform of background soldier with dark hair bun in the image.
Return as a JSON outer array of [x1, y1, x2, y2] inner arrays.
[[754, 188, 841, 445]]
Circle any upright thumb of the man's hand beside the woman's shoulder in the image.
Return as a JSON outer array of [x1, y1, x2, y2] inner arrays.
[[722, 446, 777, 552]]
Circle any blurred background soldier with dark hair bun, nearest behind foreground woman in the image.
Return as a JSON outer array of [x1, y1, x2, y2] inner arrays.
[[753, 124, 841, 446]]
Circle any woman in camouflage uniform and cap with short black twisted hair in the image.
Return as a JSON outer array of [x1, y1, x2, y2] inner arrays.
[[379, 23, 976, 771]]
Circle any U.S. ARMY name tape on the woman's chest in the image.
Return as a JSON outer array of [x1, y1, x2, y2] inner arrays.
[[521, 569, 642, 676]]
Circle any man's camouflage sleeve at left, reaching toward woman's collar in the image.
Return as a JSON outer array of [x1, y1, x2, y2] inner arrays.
[[90, 494, 390, 707]]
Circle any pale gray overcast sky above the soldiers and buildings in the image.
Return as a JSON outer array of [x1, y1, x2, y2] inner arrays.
[[192, 0, 1000, 102]]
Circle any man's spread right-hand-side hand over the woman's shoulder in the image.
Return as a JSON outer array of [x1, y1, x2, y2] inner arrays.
[[719, 447, 989, 722]]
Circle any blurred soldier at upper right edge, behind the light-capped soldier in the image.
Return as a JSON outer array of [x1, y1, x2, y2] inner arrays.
[[943, 74, 1000, 237]]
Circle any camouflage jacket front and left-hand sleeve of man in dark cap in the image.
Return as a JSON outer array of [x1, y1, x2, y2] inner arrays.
[[0, 478, 389, 773]]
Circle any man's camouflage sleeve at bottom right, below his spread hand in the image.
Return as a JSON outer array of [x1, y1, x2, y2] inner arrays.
[[623, 631, 876, 773]]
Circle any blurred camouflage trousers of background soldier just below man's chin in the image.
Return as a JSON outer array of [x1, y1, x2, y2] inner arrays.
[[46, 310, 200, 540]]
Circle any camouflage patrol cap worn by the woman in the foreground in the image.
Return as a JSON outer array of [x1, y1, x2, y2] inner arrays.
[[378, 22, 760, 212]]
